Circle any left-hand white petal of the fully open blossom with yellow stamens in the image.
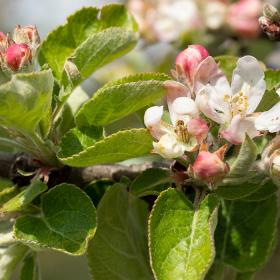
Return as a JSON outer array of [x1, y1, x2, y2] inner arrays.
[[195, 81, 231, 124]]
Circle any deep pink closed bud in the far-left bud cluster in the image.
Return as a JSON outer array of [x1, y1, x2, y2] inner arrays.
[[5, 44, 32, 71]]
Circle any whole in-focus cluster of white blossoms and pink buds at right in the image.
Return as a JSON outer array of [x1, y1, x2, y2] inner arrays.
[[144, 45, 280, 184]]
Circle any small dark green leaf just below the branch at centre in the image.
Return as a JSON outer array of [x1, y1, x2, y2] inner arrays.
[[130, 168, 174, 197]]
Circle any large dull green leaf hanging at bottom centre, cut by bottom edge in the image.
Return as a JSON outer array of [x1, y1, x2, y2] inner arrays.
[[88, 184, 153, 280]]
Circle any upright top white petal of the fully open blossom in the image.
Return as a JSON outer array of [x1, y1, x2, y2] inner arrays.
[[231, 55, 266, 114]]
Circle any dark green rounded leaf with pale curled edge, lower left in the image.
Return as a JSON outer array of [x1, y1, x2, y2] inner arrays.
[[14, 184, 96, 255]]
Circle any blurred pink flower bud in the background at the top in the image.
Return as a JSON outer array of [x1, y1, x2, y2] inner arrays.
[[228, 0, 262, 38]]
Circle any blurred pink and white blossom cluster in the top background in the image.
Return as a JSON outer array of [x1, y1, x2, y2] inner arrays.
[[128, 0, 262, 42]]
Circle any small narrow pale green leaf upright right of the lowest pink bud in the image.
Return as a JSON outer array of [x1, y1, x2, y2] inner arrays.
[[227, 135, 257, 178]]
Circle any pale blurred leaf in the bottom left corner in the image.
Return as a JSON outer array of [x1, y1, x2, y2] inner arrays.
[[0, 243, 28, 280]]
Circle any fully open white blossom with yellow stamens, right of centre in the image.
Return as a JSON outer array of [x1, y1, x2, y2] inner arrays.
[[196, 56, 266, 144]]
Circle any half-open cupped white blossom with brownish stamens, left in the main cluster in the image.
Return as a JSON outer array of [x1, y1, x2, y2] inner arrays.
[[144, 92, 208, 159]]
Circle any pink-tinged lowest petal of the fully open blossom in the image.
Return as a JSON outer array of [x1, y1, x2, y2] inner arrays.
[[220, 115, 260, 145]]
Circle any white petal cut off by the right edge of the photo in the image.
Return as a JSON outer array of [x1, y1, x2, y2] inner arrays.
[[255, 102, 280, 133]]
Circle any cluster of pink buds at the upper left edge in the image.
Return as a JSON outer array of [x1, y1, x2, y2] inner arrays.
[[0, 25, 40, 74]]
